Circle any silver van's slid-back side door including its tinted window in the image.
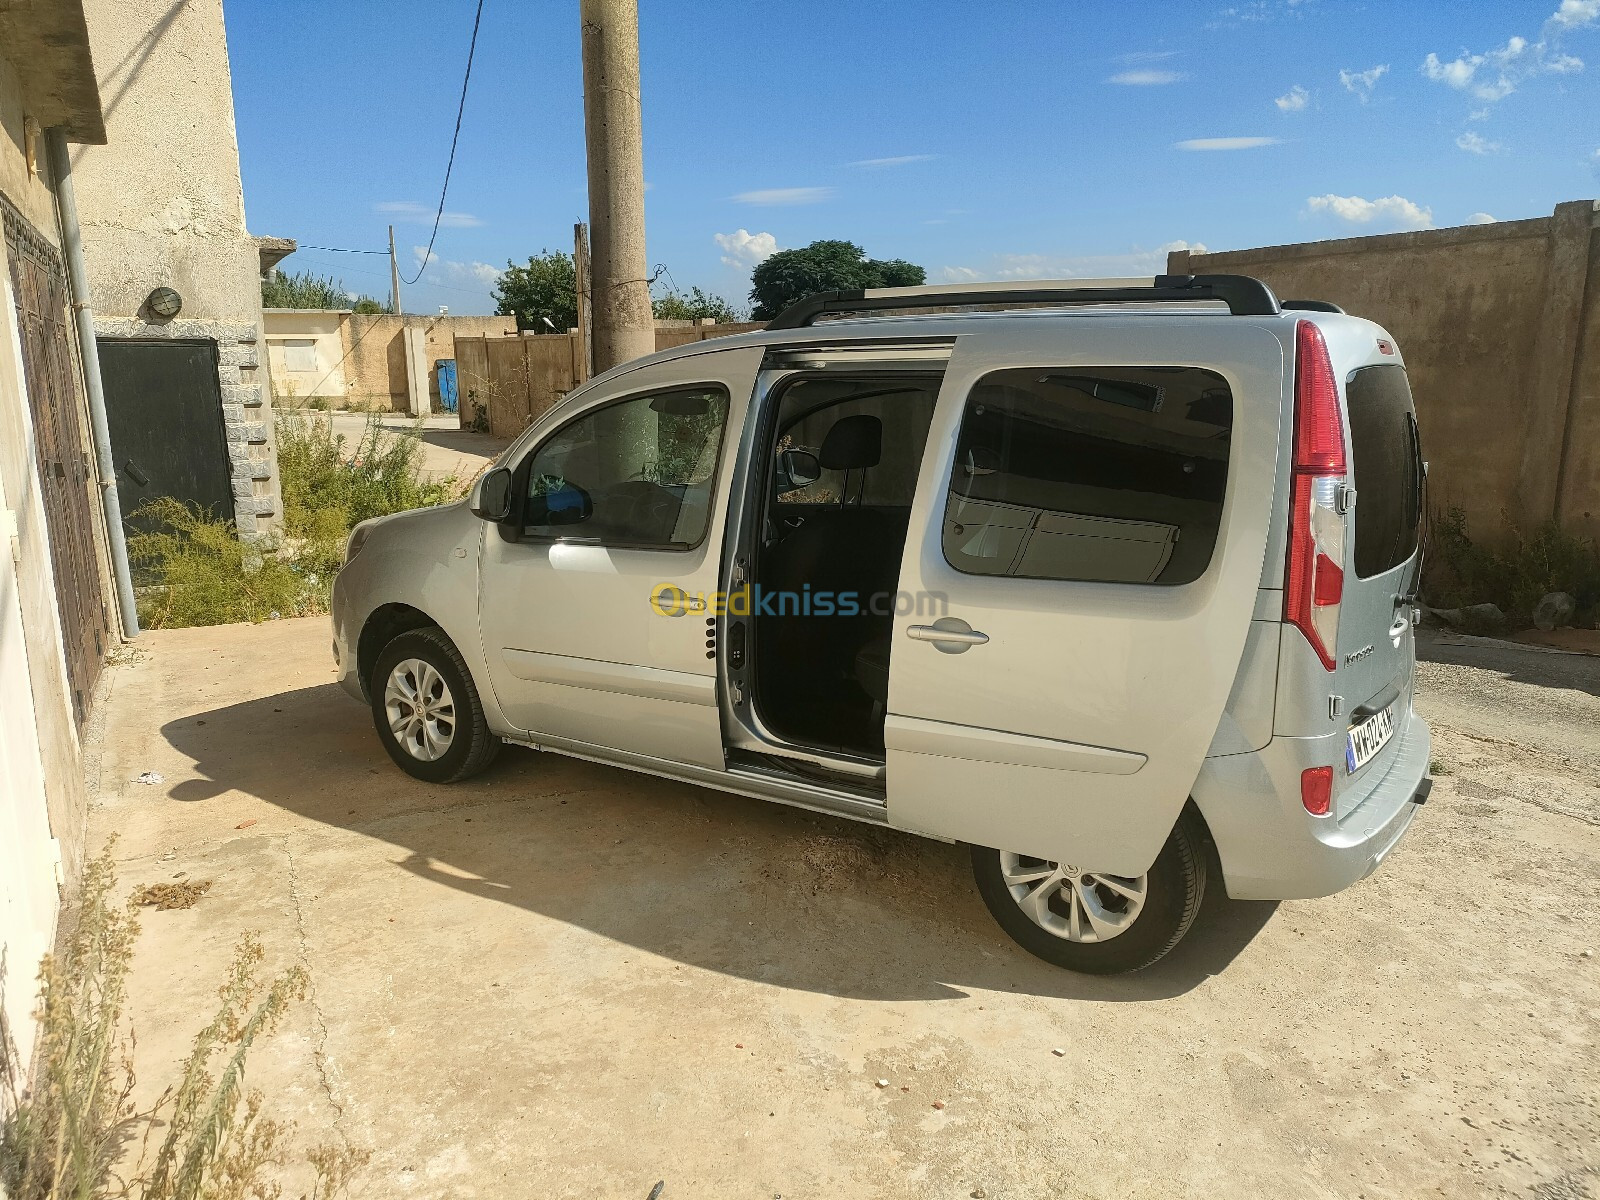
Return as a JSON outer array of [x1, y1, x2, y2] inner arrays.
[[885, 324, 1285, 875]]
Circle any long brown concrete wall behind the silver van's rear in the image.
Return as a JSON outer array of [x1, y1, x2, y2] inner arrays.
[[1168, 200, 1600, 541]]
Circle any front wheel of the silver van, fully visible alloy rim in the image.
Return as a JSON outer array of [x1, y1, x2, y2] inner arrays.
[[368, 626, 499, 784]]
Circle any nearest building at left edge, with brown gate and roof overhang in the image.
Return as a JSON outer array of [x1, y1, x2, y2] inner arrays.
[[0, 0, 117, 1062]]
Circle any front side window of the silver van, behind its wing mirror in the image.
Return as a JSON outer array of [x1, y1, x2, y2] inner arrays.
[[518, 386, 728, 550]]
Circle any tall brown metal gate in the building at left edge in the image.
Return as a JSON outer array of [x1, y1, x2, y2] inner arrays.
[[0, 197, 110, 725]]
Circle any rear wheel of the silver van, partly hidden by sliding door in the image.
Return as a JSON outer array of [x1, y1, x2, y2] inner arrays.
[[973, 811, 1208, 974]]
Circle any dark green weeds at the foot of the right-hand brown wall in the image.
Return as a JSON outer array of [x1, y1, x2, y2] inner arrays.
[[1422, 507, 1600, 626]]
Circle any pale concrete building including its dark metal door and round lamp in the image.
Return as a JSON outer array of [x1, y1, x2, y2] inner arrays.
[[74, 0, 280, 536]]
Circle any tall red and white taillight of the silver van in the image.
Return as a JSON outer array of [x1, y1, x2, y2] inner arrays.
[[1283, 322, 1346, 670]]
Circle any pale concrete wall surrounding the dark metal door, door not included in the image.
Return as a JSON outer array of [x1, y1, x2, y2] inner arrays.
[[74, 0, 280, 536]]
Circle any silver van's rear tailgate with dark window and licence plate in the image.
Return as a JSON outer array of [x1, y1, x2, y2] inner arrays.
[[1333, 350, 1422, 800]]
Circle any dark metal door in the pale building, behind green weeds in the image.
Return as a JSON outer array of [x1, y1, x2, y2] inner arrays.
[[99, 338, 234, 530]]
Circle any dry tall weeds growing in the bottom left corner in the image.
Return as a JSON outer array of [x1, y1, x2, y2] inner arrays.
[[0, 846, 366, 1200]]
